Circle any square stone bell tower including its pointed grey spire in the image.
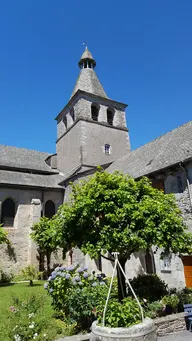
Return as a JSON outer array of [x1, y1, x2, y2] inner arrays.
[[56, 47, 130, 176]]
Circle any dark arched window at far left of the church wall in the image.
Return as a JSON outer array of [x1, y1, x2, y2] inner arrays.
[[1, 198, 15, 227]]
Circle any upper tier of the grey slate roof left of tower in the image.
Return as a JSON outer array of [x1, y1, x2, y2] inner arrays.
[[0, 145, 58, 173]]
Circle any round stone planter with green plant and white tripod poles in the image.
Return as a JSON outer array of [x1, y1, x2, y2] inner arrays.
[[90, 253, 157, 341]]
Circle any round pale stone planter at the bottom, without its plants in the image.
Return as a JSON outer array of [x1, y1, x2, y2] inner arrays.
[[90, 318, 157, 341]]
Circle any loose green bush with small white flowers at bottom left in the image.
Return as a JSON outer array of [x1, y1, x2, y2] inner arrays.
[[9, 295, 61, 341]]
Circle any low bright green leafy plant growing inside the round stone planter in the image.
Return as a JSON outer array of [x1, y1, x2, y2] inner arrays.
[[97, 297, 141, 328]]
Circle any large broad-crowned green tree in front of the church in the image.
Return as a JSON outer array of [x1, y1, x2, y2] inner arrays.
[[55, 169, 192, 299]]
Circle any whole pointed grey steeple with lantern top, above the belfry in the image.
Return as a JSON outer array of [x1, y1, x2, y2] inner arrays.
[[71, 47, 108, 98]]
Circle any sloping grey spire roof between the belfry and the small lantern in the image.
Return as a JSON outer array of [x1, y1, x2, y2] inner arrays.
[[71, 68, 108, 98]]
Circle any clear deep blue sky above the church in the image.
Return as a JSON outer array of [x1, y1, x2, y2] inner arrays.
[[0, 0, 192, 152]]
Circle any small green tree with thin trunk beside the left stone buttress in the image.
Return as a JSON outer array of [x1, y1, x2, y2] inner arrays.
[[31, 217, 61, 273]]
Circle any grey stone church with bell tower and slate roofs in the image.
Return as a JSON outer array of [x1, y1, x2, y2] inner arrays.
[[0, 48, 192, 287]]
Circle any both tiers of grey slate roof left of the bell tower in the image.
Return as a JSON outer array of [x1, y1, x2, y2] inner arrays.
[[0, 145, 63, 189]]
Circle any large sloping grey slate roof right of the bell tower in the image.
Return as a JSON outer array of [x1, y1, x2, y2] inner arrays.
[[108, 121, 192, 178]]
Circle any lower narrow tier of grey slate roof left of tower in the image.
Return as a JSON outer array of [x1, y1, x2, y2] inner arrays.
[[0, 169, 63, 189]]
